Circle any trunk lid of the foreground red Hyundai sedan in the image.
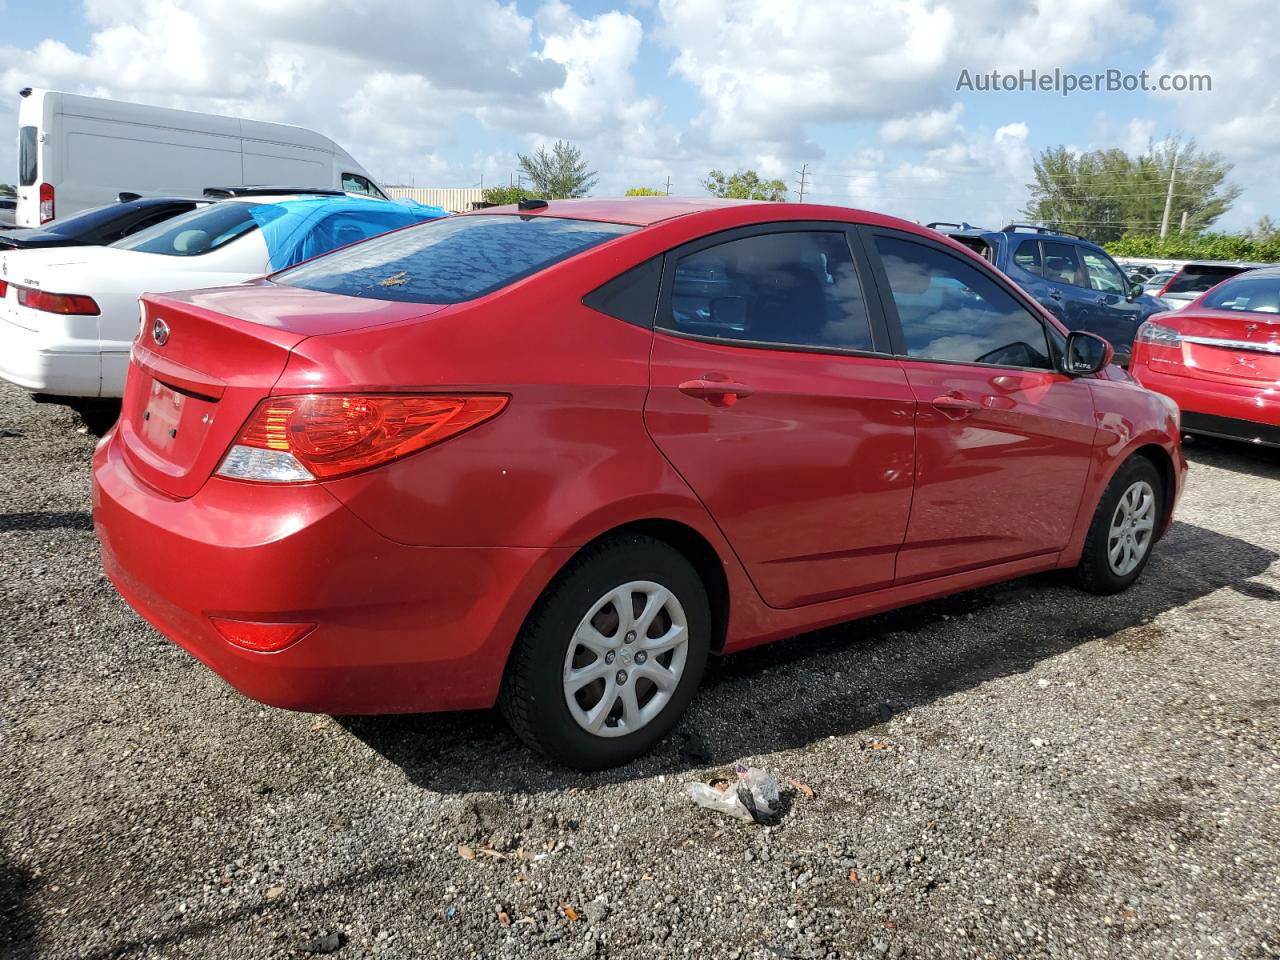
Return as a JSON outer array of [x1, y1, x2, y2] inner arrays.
[[118, 282, 440, 499]]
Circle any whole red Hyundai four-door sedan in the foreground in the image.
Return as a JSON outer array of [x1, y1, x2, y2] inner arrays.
[[93, 198, 1187, 768]]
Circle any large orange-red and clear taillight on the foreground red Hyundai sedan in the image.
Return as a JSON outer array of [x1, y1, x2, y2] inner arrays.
[[218, 393, 509, 484]]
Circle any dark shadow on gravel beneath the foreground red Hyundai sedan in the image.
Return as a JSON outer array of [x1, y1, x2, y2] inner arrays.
[[339, 522, 1280, 794]]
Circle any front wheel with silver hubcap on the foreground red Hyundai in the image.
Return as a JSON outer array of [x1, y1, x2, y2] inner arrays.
[[1075, 456, 1165, 595]]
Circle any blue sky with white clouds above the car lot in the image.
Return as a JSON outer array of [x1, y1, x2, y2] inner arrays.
[[0, 0, 1280, 230]]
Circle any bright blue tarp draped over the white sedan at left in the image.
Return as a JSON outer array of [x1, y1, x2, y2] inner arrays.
[[250, 197, 448, 270]]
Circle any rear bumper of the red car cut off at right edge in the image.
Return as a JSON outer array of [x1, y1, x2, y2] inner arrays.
[[1134, 364, 1280, 445]]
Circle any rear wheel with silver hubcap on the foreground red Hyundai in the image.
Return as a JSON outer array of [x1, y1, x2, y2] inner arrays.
[[498, 534, 710, 771]]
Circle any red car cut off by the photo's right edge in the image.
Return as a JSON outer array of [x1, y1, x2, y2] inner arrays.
[[1130, 268, 1280, 447]]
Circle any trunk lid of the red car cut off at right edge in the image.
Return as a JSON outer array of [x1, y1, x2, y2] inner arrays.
[[1157, 310, 1280, 383]]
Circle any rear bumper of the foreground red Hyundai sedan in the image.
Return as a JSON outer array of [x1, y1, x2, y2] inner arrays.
[[93, 434, 563, 714]]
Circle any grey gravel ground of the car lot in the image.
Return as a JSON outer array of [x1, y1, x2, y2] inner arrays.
[[0, 388, 1280, 960]]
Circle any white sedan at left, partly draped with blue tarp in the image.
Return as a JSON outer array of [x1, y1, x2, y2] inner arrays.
[[0, 196, 429, 399]]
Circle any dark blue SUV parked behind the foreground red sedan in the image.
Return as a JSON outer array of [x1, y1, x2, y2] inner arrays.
[[928, 223, 1169, 366]]
